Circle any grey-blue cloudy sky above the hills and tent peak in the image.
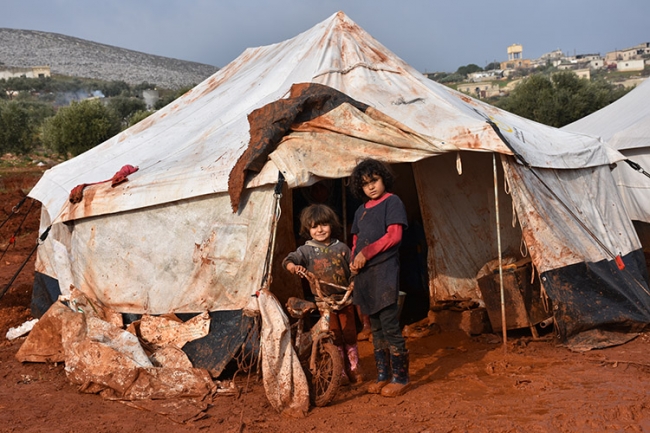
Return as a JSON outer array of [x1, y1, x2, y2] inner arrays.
[[0, 0, 650, 72]]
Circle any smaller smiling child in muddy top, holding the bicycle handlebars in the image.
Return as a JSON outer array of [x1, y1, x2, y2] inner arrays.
[[282, 204, 363, 383]]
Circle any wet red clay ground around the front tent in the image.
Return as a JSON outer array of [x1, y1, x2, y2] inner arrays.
[[0, 169, 650, 433]]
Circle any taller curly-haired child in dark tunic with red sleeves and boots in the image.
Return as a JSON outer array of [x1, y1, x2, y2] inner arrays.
[[350, 159, 409, 397]]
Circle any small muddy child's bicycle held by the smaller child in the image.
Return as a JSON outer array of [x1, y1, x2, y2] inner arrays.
[[286, 271, 354, 407]]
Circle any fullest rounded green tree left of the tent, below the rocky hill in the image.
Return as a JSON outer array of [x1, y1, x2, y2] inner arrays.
[[43, 99, 121, 156]]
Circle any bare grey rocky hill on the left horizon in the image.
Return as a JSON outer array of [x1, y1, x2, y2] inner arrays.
[[0, 28, 219, 89]]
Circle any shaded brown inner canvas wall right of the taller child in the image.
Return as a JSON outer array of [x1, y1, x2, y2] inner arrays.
[[413, 152, 526, 305]]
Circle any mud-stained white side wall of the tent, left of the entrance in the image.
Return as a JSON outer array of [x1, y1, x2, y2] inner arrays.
[[37, 186, 277, 314]]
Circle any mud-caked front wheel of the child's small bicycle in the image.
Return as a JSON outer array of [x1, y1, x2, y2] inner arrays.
[[309, 342, 343, 407]]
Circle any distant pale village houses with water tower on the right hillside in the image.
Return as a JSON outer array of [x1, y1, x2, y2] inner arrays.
[[426, 42, 650, 98]]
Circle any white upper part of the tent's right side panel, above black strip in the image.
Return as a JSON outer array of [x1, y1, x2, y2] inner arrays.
[[503, 159, 641, 273]]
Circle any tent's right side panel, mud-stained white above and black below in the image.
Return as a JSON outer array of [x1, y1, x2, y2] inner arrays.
[[503, 157, 650, 347]]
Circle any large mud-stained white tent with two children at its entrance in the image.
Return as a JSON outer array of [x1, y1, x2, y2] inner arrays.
[[29, 12, 650, 362]]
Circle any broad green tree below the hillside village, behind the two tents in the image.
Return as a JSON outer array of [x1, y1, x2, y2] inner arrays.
[[496, 71, 628, 128]]
